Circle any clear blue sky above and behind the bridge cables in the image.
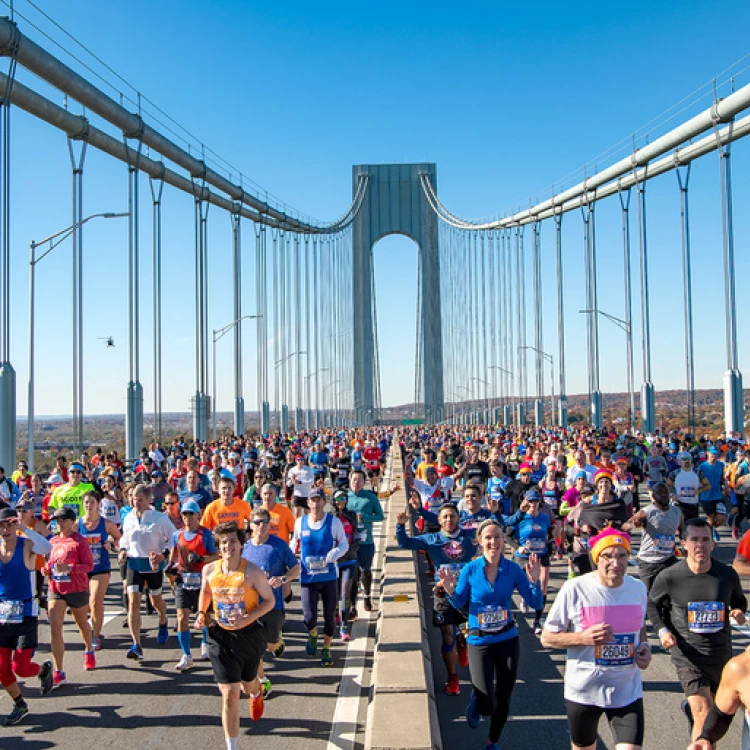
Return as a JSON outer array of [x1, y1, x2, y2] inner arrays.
[[5, 0, 750, 414]]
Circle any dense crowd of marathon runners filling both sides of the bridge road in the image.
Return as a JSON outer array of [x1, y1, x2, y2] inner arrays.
[[0, 425, 750, 750]]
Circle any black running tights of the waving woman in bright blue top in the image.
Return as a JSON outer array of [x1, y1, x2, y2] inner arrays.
[[469, 636, 519, 742]]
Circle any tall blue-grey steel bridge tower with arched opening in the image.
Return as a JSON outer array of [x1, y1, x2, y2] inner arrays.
[[352, 164, 444, 424]]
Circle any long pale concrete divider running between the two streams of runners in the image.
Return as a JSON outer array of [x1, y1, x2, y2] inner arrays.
[[365, 436, 442, 750]]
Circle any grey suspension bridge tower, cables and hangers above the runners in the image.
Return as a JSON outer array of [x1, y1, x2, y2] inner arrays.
[[0, 11, 750, 472]]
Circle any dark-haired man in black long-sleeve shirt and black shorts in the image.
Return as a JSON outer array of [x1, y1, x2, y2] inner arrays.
[[648, 518, 747, 740]]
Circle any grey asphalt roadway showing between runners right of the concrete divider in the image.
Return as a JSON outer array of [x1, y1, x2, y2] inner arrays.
[[420, 528, 750, 750]]
